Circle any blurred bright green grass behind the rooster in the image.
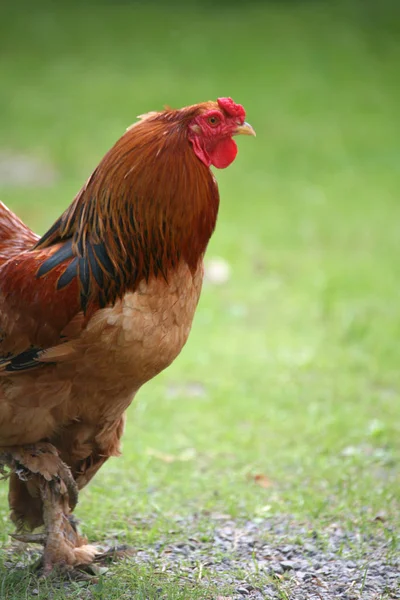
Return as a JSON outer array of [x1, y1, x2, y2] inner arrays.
[[0, 0, 400, 599]]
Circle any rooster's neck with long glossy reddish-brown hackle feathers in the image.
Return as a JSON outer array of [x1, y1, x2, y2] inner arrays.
[[37, 124, 219, 310]]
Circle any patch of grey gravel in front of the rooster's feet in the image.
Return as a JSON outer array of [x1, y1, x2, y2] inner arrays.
[[129, 518, 400, 600]]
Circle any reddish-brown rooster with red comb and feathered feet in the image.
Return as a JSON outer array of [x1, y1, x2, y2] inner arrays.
[[0, 98, 255, 573]]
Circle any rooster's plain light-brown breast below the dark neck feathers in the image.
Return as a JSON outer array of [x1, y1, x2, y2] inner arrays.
[[72, 263, 203, 393]]
